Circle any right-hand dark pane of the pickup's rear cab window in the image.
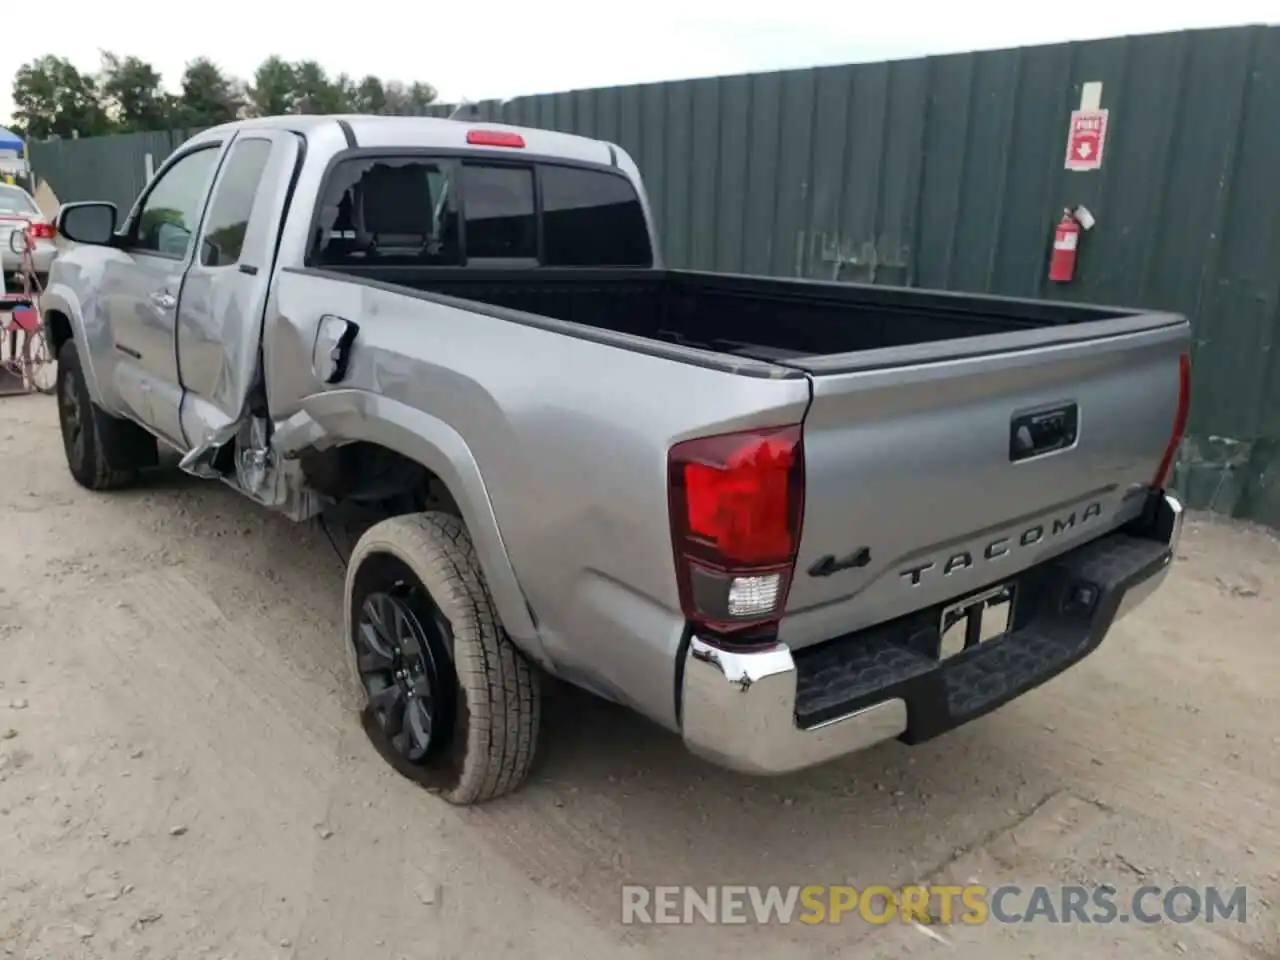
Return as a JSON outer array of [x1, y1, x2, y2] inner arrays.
[[541, 165, 653, 266]]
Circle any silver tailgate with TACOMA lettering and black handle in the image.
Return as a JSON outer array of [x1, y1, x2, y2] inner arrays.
[[780, 315, 1189, 646]]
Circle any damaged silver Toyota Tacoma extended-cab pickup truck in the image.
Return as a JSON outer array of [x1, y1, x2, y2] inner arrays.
[[44, 110, 1190, 803]]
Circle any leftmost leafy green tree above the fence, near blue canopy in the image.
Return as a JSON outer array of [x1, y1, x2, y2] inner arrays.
[[13, 55, 113, 140]]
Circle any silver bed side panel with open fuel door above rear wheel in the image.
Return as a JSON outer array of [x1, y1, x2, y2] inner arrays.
[[266, 270, 809, 727]]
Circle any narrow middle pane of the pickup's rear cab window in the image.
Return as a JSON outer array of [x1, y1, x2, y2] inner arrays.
[[462, 164, 538, 260]]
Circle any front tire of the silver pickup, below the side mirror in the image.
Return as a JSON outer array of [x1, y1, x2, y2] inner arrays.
[[55, 340, 157, 490]]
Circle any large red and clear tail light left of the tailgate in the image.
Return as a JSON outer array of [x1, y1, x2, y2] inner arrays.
[[668, 426, 804, 641]]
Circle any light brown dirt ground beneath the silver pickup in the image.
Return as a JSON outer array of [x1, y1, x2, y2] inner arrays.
[[0, 397, 1280, 960]]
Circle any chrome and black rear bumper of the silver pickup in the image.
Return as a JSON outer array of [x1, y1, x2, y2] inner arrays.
[[680, 494, 1183, 774]]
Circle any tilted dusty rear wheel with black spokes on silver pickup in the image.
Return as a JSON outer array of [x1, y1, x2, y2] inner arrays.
[[344, 512, 541, 805]]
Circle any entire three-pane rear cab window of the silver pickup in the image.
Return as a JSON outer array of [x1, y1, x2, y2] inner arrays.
[[308, 155, 653, 268]]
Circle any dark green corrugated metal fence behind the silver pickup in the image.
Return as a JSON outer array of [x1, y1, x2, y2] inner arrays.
[[32, 27, 1280, 525]]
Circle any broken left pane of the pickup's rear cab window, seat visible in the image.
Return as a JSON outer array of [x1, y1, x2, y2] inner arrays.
[[312, 157, 462, 266]]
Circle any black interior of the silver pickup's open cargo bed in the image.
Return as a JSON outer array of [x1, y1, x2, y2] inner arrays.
[[320, 266, 1123, 361]]
